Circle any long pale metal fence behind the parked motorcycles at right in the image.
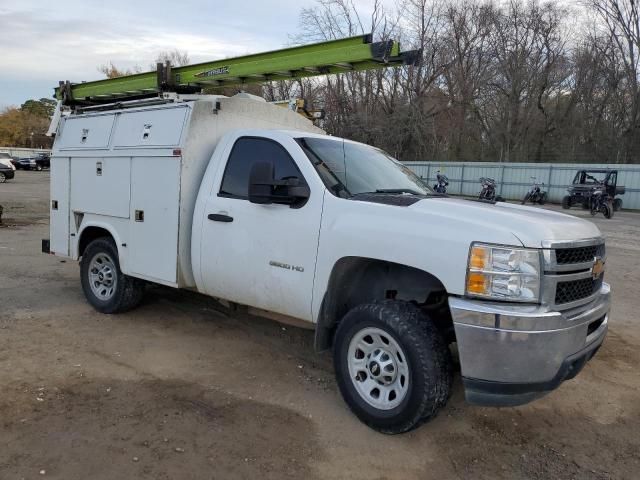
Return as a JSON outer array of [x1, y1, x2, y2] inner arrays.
[[404, 162, 640, 209]]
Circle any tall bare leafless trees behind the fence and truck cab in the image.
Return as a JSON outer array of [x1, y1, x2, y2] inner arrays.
[[264, 0, 640, 163]]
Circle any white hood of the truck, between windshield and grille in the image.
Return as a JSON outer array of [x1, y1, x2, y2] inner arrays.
[[408, 198, 602, 248]]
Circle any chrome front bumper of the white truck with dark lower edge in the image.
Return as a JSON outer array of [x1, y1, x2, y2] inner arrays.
[[449, 283, 611, 406]]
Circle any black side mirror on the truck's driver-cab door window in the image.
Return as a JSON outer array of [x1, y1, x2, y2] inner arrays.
[[249, 162, 310, 206]]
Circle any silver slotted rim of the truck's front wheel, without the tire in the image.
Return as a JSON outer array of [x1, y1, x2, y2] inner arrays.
[[347, 328, 409, 410]]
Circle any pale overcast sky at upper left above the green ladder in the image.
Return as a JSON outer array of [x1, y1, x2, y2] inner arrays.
[[0, 0, 384, 108]]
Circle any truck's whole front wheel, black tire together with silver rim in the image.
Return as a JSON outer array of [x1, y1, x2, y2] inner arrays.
[[334, 300, 451, 434]]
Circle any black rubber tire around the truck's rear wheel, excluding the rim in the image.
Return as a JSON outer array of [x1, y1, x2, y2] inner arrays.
[[80, 237, 145, 313]]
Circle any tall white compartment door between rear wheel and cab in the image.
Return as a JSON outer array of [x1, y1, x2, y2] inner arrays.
[[128, 157, 181, 285]]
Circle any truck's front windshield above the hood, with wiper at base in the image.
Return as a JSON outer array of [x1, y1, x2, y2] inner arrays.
[[297, 137, 433, 198]]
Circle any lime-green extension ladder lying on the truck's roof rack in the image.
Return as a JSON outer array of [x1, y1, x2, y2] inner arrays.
[[54, 34, 421, 105]]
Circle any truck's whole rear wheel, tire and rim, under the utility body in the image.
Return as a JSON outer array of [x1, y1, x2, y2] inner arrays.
[[80, 237, 144, 313]]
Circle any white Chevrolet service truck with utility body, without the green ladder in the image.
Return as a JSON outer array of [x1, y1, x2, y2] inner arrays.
[[43, 94, 610, 433]]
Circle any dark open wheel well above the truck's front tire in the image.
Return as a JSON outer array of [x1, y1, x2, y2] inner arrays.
[[314, 256, 453, 351]]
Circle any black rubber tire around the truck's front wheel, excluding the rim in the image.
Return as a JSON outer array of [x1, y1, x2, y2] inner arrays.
[[333, 300, 452, 434]]
